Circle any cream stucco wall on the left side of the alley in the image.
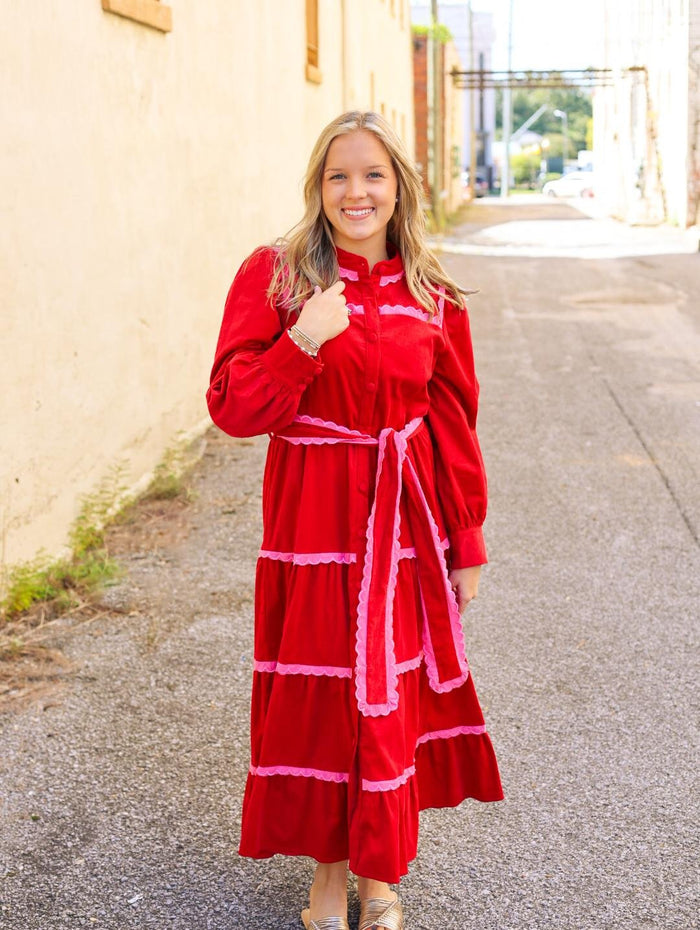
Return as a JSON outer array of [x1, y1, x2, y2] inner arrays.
[[0, 0, 413, 565]]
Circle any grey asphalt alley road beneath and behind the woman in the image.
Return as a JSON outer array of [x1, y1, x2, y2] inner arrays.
[[0, 200, 700, 930]]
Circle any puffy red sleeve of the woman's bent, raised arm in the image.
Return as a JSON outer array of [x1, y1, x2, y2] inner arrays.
[[207, 248, 323, 436]]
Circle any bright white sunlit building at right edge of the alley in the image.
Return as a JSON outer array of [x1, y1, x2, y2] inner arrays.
[[593, 0, 700, 227]]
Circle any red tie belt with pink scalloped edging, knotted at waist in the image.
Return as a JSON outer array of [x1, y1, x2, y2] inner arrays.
[[272, 416, 469, 717]]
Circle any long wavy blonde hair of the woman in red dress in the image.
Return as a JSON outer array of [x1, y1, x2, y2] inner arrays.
[[268, 110, 472, 314]]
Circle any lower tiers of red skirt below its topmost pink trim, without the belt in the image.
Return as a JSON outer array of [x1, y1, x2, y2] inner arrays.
[[240, 546, 503, 882]]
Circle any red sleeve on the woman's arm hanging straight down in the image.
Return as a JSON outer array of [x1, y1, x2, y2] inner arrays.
[[428, 301, 487, 568]]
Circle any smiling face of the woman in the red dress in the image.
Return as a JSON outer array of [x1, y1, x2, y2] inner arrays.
[[321, 129, 398, 263]]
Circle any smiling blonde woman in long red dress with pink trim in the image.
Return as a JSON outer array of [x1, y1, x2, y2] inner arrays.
[[207, 112, 502, 930]]
